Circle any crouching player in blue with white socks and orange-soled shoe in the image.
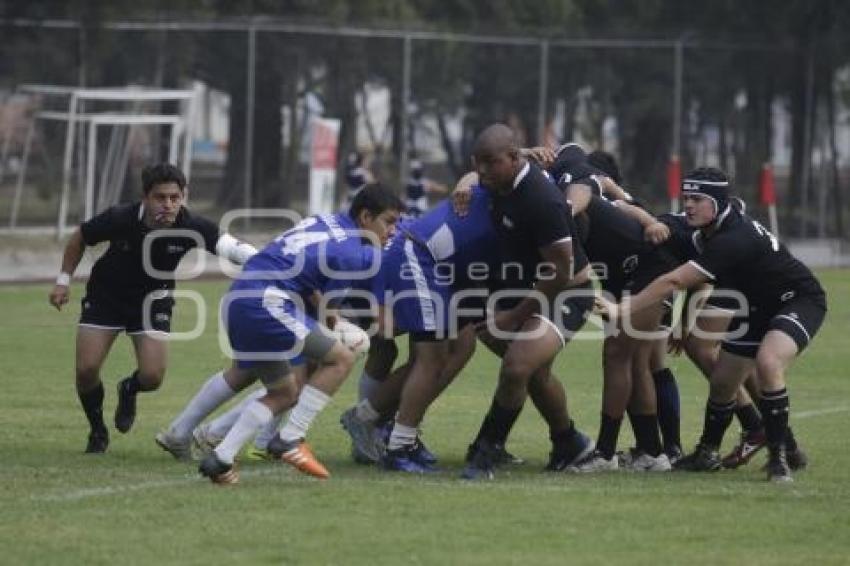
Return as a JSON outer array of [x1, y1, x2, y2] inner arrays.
[[156, 184, 403, 483]]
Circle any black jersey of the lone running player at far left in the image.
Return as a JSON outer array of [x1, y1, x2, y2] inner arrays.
[[80, 202, 219, 301]]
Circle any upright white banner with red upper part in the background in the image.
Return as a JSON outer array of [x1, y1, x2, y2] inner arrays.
[[307, 118, 340, 215]]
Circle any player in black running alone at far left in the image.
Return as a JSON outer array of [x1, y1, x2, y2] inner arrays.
[[49, 163, 256, 453]]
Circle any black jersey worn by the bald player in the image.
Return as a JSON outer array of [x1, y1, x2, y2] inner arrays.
[[492, 163, 588, 286]]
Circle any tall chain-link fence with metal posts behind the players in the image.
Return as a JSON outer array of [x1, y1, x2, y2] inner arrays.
[[0, 20, 850, 241]]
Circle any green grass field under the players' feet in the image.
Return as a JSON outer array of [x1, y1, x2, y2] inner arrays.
[[0, 271, 850, 565]]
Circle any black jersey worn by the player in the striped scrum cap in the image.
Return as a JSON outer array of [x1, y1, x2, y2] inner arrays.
[[690, 207, 824, 306]]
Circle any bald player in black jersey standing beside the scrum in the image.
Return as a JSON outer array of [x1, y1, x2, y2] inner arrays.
[[462, 124, 593, 479]]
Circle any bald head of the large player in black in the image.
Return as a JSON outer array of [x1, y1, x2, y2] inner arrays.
[[472, 124, 525, 193]]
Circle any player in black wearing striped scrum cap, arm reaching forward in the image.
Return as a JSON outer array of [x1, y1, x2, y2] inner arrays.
[[600, 168, 826, 482]]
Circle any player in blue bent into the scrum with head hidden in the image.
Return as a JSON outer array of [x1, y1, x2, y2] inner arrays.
[[342, 183, 501, 473]]
